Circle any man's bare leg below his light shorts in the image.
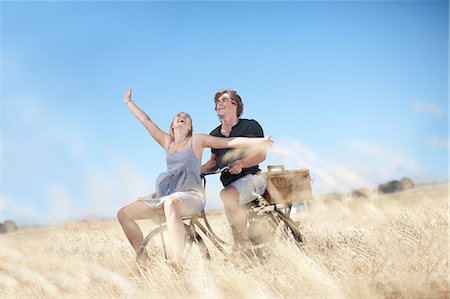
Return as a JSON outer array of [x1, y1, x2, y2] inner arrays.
[[220, 186, 249, 245]]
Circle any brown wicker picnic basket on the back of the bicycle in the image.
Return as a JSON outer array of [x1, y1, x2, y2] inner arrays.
[[262, 165, 313, 204]]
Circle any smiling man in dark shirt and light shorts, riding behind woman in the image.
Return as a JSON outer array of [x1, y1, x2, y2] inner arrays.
[[201, 89, 266, 248]]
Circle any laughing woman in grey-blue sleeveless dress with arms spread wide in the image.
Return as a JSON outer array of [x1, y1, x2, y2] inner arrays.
[[117, 89, 272, 264]]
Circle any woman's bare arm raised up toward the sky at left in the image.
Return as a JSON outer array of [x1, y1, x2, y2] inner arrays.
[[123, 88, 171, 149]]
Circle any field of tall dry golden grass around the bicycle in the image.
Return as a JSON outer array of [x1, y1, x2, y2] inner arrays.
[[0, 183, 449, 298]]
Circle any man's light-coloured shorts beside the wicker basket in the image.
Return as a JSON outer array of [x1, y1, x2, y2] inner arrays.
[[229, 174, 267, 205]]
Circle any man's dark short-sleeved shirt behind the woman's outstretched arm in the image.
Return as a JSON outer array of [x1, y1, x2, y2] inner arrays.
[[209, 119, 264, 187]]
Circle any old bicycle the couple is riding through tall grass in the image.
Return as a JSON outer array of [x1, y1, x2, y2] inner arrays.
[[136, 166, 305, 261]]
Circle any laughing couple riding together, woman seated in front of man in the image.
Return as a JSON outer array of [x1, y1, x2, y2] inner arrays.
[[117, 89, 272, 264]]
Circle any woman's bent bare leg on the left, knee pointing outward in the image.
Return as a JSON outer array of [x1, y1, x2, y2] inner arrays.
[[117, 200, 155, 252]]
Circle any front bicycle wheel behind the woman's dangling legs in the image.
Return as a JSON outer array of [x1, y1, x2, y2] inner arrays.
[[136, 224, 210, 262]]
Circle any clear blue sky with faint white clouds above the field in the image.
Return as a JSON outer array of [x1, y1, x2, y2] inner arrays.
[[0, 1, 449, 225]]
